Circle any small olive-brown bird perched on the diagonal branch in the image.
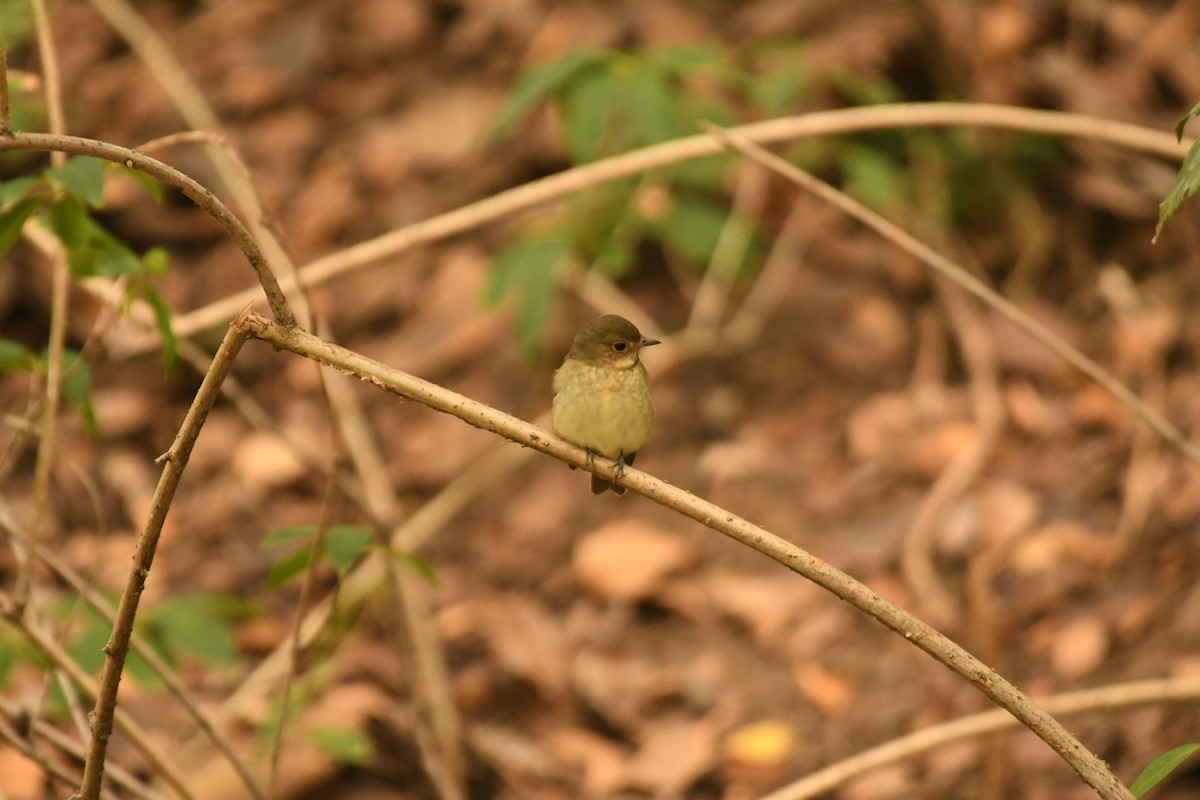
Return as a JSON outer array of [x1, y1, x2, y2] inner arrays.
[[550, 314, 660, 494]]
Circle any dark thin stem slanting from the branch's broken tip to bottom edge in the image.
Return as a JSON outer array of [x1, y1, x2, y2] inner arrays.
[[78, 316, 246, 800]]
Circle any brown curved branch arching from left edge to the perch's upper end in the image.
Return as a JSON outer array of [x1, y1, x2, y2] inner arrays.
[[0, 133, 296, 326]]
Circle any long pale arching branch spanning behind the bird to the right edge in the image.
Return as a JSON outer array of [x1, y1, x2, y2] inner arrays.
[[121, 103, 1192, 355]]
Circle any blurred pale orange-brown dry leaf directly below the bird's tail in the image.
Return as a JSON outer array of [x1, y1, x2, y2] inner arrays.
[[571, 518, 696, 601]]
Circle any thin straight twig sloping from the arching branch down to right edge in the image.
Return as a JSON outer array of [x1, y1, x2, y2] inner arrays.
[[704, 125, 1200, 465]]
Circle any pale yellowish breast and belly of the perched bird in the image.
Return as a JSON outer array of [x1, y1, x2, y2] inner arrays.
[[551, 360, 654, 458]]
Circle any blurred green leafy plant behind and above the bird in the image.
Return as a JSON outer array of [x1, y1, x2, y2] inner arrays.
[[484, 43, 809, 357]]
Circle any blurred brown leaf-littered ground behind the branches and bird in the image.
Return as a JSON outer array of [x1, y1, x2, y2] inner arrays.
[[0, 0, 1200, 800]]
